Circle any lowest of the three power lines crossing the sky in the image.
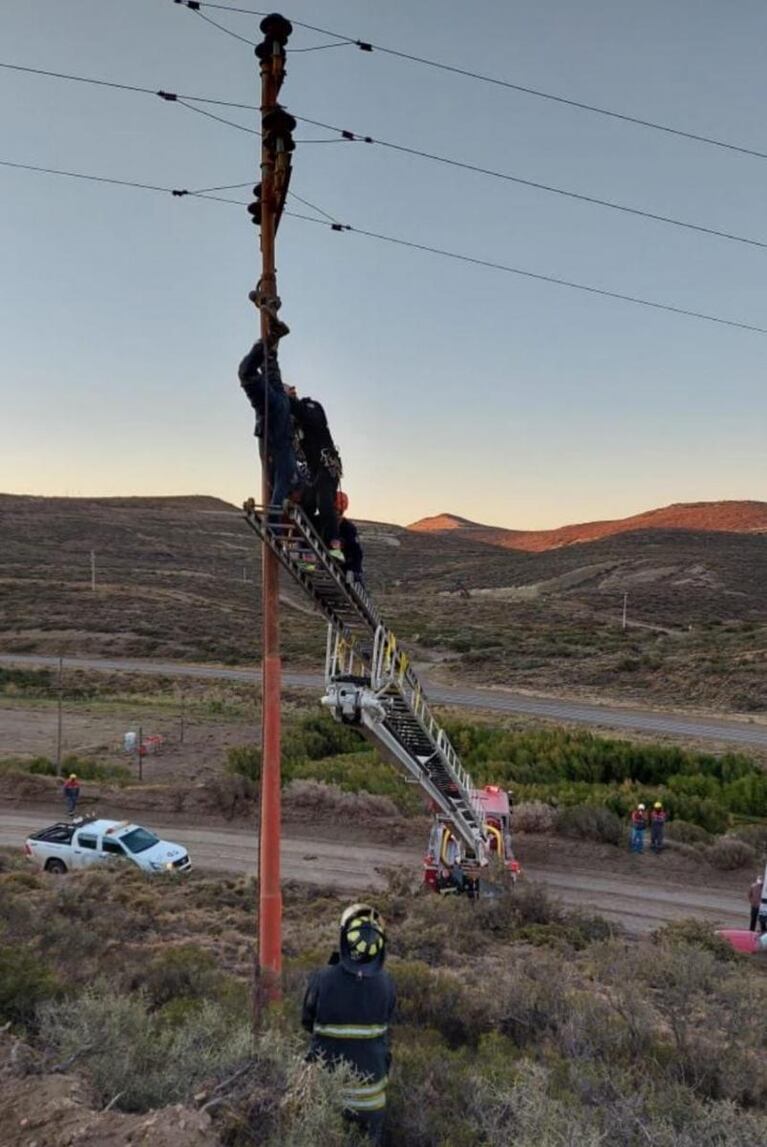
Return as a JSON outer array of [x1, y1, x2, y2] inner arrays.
[[0, 153, 767, 335]]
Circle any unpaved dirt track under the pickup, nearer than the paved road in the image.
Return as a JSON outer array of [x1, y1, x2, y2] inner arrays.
[[0, 809, 745, 933]]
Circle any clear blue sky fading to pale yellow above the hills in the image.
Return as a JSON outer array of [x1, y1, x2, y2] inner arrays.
[[0, 0, 767, 529]]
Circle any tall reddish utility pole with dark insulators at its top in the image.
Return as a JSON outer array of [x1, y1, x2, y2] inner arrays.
[[251, 13, 295, 1021]]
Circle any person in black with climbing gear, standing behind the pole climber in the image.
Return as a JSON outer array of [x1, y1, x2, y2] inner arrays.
[[288, 387, 344, 563]]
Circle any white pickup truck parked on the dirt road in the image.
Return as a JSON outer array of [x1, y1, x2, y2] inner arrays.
[[24, 817, 191, 873]]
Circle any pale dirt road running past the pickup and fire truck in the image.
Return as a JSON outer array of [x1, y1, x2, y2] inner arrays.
[[0, 803, 753, 934]]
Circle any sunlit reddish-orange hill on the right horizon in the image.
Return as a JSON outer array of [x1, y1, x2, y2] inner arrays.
[[408, 501, 767, 553]]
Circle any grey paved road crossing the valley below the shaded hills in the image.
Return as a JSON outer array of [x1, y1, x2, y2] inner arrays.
[[0, 654, 767, 749]]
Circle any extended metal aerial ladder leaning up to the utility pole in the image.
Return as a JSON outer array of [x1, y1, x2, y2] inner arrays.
[[243, 500, 519, 891]]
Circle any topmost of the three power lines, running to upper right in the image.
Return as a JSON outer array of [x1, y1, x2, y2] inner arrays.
[[192, 0, 767, 159]]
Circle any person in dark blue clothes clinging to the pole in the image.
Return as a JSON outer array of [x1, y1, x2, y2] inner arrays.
[[237, 290, 299, 516]]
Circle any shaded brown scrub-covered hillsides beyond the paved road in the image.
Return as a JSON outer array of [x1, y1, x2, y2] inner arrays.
[[0, 494, 767, 712]]
